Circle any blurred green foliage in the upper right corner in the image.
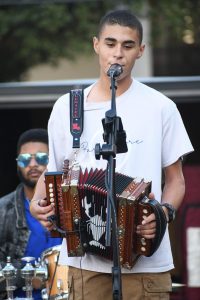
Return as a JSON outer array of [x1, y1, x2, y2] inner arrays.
[[147, 0, 200, 47]]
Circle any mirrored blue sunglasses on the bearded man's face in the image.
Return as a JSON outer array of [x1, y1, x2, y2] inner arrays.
[[16, 152, 49, 168]]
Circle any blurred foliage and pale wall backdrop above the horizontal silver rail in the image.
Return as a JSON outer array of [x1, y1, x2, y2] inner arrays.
[[0, 0, 200, 82]]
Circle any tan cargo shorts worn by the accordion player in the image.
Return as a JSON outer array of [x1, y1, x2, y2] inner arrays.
[[69, 267, 172, 300]]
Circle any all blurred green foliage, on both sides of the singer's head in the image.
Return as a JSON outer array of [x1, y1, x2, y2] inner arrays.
[[0, 0, 200, 82]]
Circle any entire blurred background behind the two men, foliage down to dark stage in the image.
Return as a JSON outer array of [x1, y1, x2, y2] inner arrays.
[[0, 0, 200, 300]]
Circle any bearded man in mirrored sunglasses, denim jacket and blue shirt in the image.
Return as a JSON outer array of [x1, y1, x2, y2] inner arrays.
[[0, 128, 61, 299]]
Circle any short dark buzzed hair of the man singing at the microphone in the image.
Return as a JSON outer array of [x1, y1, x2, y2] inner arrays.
[[98, 9, 143, 44]]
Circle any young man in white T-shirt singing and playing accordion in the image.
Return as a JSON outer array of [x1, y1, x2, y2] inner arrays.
[[31, 10, 193, 300]]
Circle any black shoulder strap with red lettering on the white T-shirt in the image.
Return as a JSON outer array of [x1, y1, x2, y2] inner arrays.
[[70, 89, 84, 148]]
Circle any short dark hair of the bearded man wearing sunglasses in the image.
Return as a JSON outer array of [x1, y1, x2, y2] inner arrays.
[[17, 128, 48, 154]]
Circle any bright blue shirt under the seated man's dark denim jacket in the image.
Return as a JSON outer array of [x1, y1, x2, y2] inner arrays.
[[15, 199, 62, 300]]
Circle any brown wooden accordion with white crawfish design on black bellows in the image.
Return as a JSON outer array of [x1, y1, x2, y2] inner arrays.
[[45, 161, 166, 269]]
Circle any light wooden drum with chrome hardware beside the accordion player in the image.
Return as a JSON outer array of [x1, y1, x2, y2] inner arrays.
[[41, 245, 68, 300]]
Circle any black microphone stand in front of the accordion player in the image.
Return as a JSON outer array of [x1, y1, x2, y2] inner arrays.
[[95, 68, 127, 300]]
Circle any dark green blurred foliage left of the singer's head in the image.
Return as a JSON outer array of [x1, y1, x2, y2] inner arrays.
[[0, 1, 112, 82]]
